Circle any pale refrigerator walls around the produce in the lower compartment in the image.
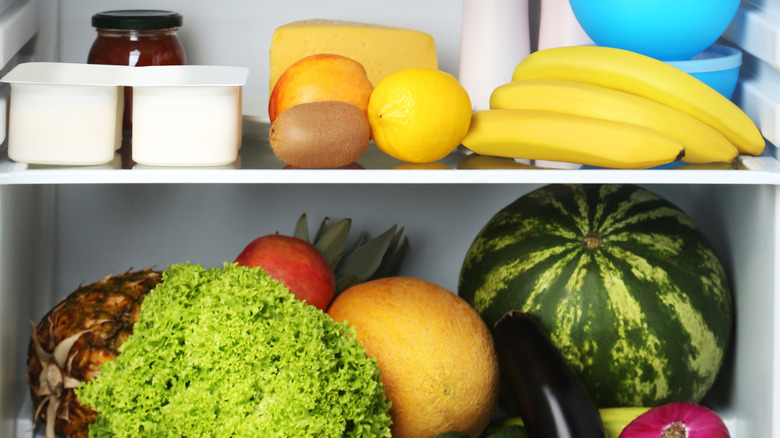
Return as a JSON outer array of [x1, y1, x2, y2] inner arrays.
[[0, 184, 779, 437]]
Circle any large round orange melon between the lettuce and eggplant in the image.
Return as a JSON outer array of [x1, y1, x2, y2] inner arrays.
[[328, 277, 499, 438]]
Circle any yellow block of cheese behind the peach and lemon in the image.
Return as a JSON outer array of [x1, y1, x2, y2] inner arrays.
[[269, 19, 438, 91]]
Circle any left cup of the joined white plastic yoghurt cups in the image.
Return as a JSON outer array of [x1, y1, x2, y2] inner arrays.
[[2, 63, 122, 165]]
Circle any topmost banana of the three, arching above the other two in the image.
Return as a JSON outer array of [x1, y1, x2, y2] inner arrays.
[[512, 46, 766, 155]]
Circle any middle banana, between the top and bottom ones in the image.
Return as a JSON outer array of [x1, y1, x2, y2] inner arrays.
[[490, 79, 739, 163]]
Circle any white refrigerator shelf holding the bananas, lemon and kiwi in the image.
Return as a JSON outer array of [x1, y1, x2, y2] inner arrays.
[[0, 121, 780, 185]]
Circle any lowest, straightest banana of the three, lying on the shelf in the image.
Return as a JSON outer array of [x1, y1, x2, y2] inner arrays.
[[461, 109, 684, 168]]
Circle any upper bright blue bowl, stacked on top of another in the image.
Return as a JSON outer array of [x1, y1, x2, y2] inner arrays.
[[570, 0, 740, 61]]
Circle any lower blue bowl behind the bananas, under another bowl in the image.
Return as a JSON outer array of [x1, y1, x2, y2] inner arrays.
[[666, 44, 742, 99]]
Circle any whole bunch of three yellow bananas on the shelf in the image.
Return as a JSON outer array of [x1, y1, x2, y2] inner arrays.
[[462, 46, 765, 168]]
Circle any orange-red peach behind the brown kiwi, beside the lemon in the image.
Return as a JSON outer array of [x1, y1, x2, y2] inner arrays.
[[268, 53, 374, 122]]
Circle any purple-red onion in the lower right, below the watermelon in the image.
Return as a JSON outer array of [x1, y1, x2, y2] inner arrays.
[[619, 402, 730, 438]]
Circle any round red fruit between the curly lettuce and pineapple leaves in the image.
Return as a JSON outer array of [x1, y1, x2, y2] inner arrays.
[[236, 234, 336, 311]]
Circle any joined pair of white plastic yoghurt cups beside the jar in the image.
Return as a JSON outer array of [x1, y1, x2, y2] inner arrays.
[[2, 62, 249, 166]]
